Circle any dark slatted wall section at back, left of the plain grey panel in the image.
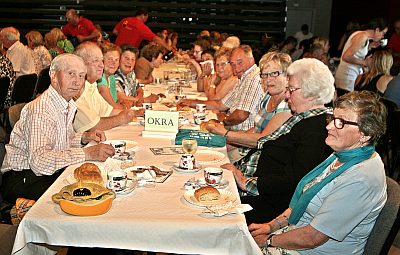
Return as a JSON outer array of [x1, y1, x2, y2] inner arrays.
[[0, 0, 286, 47]]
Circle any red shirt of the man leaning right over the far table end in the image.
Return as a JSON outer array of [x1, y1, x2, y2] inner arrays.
[[114, 17, 156, 48]]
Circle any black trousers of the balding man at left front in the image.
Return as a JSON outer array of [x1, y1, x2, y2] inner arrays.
[[1, 169, 64, 204]]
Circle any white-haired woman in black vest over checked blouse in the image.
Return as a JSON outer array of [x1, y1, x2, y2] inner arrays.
[[221, 59, 335, 224]]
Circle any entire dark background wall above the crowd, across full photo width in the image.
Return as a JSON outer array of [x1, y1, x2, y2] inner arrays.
[[0, 0, 400, 54]]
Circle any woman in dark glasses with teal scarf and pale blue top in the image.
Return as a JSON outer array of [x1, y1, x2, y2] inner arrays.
[[249, 91, 387, 254]]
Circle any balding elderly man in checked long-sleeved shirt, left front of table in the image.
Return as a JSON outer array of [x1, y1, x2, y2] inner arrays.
[[1, 54, 115, 203]]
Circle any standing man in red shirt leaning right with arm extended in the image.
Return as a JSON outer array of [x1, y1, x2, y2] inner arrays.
[[113, 8, 171, 50]]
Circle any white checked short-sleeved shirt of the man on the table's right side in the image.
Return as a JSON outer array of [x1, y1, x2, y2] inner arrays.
[[222, 65, 264, 131]]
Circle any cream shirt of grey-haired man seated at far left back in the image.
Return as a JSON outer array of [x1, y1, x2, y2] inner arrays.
[[6, 41, 36, 77]]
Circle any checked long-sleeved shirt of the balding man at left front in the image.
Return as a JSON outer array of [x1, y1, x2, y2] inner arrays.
[[1, 86, 85, 176]]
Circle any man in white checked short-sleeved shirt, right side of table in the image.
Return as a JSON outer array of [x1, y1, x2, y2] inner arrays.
[[179, 45, 264, 131]]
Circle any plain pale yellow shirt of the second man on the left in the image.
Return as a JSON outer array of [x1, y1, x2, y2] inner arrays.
[[73, 81, 113, 132]]
